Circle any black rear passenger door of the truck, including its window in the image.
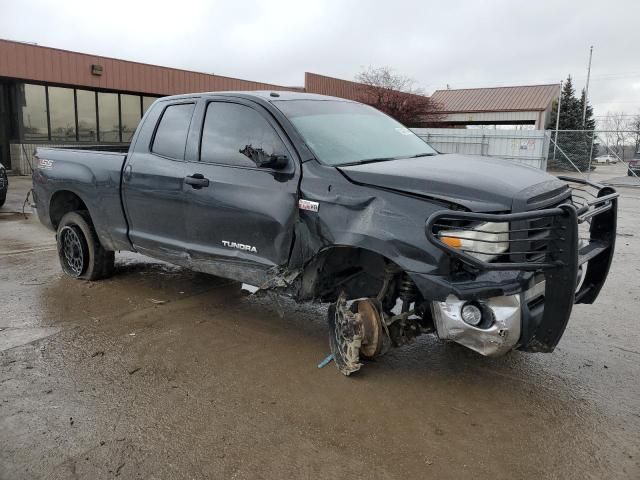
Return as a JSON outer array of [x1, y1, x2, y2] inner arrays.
[[122, 100, 196, 264]]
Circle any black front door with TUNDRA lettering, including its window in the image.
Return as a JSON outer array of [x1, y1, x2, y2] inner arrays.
[[180, 98, 300, 284]]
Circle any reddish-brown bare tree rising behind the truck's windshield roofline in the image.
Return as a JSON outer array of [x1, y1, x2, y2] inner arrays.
[[356, 67, 443, 126]]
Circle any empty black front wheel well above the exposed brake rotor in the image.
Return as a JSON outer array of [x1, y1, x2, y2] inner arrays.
[[302, 246, 392, 302]]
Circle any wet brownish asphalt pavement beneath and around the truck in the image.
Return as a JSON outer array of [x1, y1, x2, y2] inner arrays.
[[0, 173, 640, 480]]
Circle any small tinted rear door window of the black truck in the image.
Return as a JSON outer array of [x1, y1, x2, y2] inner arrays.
[[151, 103, 195, 160]]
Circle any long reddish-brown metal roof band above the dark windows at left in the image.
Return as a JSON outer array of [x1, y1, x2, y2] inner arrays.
[[0, 39, 300, 95]]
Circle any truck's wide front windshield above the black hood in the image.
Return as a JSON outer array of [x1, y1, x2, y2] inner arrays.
[[273, 100, 437, 166]]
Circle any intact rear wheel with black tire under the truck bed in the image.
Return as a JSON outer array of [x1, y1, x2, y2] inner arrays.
[[56, 210, 115, 280]]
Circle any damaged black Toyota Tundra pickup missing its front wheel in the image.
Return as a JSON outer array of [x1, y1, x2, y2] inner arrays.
[[33, 92, 618, 375]]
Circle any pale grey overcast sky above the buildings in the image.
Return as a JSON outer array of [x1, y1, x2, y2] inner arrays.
[[0, 0, 640, 119]]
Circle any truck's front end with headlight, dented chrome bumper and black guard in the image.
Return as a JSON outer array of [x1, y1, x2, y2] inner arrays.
[[417, 179, 618, 356]]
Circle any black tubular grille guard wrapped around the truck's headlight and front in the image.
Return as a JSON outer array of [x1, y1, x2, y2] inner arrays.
[[425, 177, 618, 352]]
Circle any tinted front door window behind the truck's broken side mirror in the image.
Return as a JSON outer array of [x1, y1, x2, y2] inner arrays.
[[200, 102, 286, 167]]
